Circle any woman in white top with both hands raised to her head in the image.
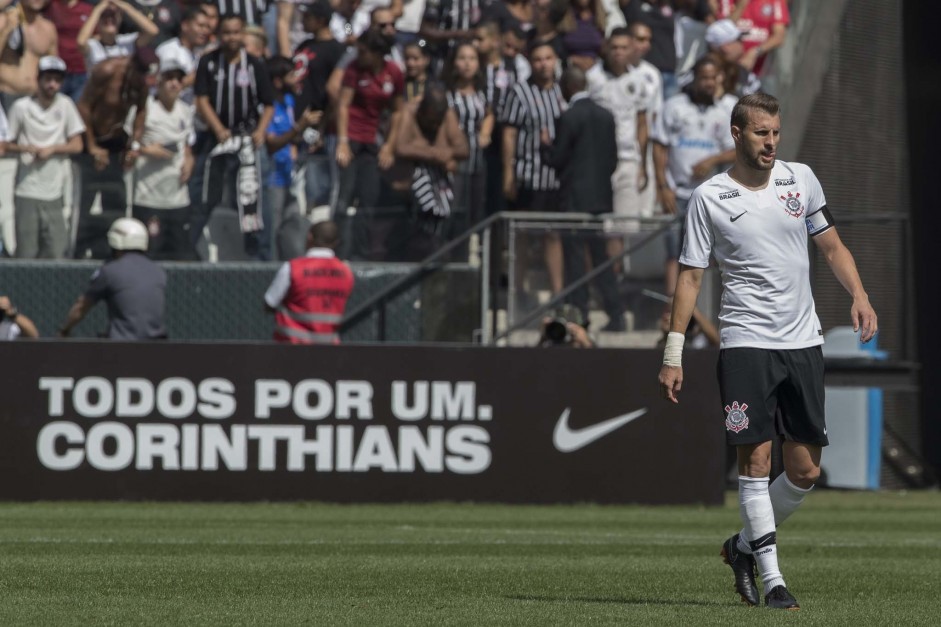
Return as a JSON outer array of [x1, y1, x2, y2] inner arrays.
[[76, 0, 160, 72]]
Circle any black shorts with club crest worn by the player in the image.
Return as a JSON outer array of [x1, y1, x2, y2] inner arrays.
[[718, 346, 830, 446]]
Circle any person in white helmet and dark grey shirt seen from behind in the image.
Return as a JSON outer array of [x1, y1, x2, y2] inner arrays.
[[59, 218, 167, 340]]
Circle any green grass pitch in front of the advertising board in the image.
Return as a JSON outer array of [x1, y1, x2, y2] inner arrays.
[[0, 490, 941, 627]]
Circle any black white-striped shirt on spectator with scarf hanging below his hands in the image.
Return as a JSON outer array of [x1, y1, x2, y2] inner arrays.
[[194, 50, 274, 134]]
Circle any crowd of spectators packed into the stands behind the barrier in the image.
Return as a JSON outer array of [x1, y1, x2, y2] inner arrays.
[[0, 0, 789, 302]]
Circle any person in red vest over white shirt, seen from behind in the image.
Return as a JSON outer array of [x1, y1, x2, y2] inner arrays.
[[265, 220, 353, 344]]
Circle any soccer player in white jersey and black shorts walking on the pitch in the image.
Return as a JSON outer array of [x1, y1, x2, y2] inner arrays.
[[660, 94, 878, 610]]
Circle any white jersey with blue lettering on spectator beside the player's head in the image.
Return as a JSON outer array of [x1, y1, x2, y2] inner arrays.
[[652, 93, 735, 198]]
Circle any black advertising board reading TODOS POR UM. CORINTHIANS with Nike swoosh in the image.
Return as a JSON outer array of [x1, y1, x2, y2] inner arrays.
[[0, 342, 725, 504]]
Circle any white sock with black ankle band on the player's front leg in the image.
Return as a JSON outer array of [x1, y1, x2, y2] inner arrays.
[[738, 477, 784, 594]]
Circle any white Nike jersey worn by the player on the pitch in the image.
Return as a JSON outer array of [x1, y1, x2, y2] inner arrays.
[[680, 161, 830, 349]]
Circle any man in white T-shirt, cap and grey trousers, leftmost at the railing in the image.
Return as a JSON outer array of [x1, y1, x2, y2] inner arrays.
[[7, 56, 85, 259]]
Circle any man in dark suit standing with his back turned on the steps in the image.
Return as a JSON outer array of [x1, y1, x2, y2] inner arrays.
[[546, 67, 625, 331]]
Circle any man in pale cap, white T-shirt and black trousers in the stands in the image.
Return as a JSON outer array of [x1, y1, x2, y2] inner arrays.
[[134, 59, 195, 260]]
